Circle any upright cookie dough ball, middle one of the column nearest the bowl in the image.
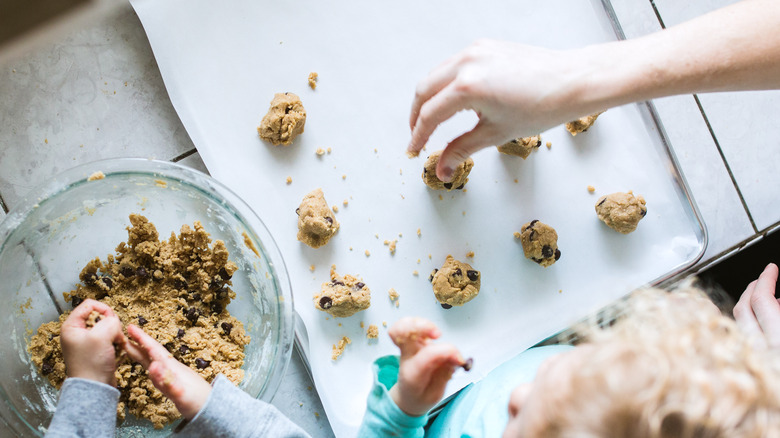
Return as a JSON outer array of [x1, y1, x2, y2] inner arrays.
[[295, 189, 339, 248]]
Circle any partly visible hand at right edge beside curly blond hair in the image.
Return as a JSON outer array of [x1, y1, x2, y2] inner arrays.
[[734, 263, 780, 348]]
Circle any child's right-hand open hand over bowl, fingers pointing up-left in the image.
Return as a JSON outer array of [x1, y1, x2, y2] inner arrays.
[[125, 324, 211, 420]]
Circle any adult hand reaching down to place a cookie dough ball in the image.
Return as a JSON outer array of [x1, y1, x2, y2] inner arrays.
[[408, 40, 605, 181]]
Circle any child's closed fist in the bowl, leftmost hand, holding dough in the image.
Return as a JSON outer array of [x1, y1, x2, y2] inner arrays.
[[60, 299, 126, 386]]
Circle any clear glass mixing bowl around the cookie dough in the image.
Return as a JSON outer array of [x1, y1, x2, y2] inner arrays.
[[0, 159, 293, 437]]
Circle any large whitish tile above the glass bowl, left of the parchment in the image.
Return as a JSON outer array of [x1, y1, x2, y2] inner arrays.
[[0, 5, 194, 208]]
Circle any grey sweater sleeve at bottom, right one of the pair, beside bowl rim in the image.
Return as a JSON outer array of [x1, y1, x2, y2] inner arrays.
[[177, 374, 309, 438]]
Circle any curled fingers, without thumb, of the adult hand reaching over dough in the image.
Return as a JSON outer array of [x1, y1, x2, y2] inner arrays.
[[407, 82, 467, 155]]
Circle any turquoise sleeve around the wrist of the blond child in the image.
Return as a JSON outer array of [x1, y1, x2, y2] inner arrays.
[[358, 356, 428, 438]]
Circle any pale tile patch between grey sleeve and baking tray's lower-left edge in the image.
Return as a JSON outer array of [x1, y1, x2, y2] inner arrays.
[[271, 350, 336, 438]]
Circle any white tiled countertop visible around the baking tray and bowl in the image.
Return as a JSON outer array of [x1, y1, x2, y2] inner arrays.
[[0, 0, 780, 437]]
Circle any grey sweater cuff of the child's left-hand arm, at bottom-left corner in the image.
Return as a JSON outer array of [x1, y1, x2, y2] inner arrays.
[[46, 377, 119, 438]]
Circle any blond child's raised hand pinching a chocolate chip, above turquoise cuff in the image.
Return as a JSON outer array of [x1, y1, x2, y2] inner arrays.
[[388, 318, 464, 417]]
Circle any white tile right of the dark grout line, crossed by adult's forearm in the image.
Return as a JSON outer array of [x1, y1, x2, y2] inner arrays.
[[655, 0, 780, 231]]
